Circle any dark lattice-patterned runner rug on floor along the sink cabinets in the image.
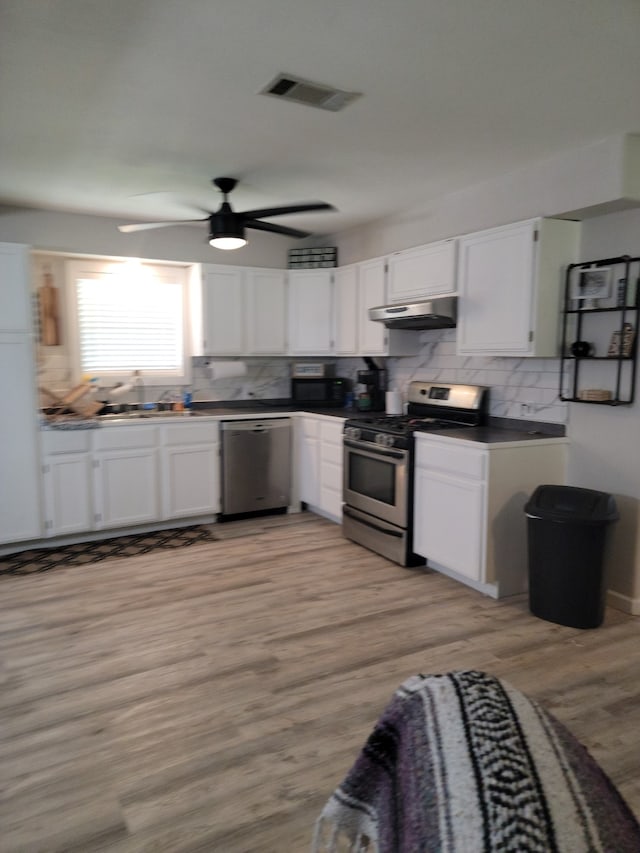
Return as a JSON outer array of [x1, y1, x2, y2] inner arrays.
[[0, 524, 218, 577]]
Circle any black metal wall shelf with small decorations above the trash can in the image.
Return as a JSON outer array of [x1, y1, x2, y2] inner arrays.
[[560, 255, 640, 406]]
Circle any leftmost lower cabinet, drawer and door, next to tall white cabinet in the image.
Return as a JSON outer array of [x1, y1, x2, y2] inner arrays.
[[42, 430, 94, 536]]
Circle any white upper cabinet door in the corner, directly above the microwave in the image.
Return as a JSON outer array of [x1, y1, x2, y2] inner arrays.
[[289, 270, 333, 355]]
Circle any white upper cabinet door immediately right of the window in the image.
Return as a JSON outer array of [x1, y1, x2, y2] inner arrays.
[[202, 265, 246, 355]]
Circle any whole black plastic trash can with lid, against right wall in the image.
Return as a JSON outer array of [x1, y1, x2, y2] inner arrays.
[[524, 486, 618, 628]]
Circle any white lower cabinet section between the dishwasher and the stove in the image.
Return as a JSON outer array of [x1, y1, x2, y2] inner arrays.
[[297, 415, 344, 522]]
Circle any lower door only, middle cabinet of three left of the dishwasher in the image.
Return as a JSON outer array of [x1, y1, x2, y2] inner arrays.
[[94, 448, 160, 528]]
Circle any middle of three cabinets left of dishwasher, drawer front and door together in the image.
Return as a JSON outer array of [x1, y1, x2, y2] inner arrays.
[[93, 425, 160, 529]]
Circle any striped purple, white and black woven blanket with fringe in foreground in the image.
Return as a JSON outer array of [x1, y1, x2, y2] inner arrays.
[[313, 672, 640, 853]]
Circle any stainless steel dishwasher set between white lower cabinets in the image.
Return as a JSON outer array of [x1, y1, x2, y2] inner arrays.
[[221, 418, 291, 516]]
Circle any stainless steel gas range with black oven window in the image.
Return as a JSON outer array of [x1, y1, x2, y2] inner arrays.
[[342, 382, 489, 566]]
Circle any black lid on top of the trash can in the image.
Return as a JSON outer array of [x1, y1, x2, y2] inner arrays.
[[524, 485, 619, 524]]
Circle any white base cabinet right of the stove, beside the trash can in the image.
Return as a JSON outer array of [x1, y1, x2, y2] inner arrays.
[[413, 435, 566, 598]]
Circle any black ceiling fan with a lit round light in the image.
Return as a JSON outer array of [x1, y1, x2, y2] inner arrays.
[[118, 178, 335, 249]]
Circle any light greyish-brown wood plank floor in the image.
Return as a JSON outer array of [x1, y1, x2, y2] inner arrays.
[[0, 513, 640, 853]]
